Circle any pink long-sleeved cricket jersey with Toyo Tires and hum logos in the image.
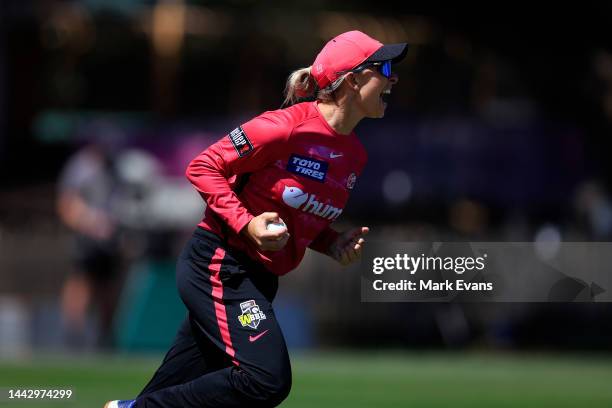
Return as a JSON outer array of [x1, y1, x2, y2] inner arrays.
[[186, 102, 367, 275]]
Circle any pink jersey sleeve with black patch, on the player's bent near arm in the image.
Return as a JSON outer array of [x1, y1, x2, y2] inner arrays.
[[186, 111, 292, 234]]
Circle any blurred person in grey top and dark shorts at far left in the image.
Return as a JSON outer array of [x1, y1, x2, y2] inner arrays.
[[57, 143, 120, 348]]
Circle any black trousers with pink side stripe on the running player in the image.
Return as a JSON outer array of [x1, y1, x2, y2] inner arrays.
[[135, 228, 291, 408]]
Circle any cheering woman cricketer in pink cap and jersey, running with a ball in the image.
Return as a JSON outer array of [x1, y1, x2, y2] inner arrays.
[[105, 31, 407, 408]]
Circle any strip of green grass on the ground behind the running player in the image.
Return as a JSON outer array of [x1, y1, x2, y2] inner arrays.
[[0, 352, 612, 408]]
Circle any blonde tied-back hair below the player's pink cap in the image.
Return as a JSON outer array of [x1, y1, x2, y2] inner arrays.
[[282, 67, 344, 107]]
